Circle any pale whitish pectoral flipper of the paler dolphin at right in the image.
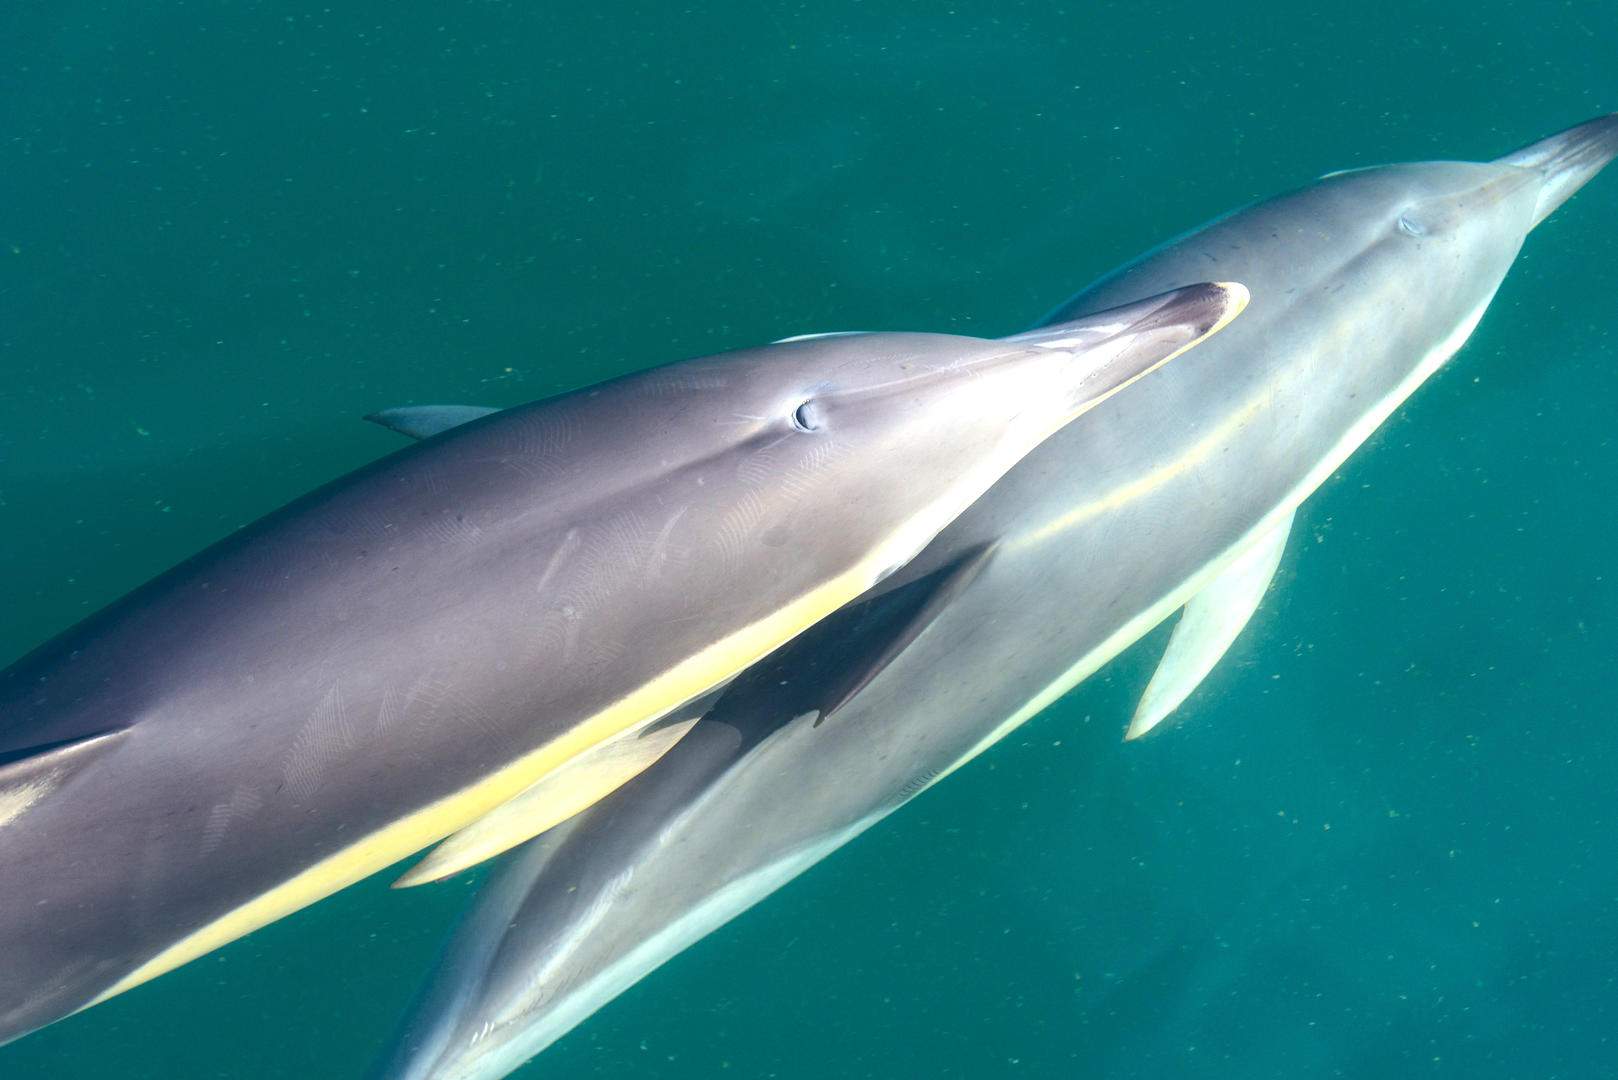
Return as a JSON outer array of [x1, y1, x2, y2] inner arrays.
[[1125, 513, 1293, 738]]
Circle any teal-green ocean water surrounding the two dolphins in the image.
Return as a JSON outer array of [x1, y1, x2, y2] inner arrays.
[[0, 0, 1618, 1080]]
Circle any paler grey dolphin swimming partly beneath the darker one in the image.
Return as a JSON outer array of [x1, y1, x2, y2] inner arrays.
[[379, 117, 1618, 1080]]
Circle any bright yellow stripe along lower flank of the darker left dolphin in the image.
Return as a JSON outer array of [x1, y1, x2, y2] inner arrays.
[[83, 550, 914, 1009]]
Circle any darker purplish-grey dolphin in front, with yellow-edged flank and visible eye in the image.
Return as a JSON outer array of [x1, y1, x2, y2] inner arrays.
[[0, 285, 1246, 1043]]
